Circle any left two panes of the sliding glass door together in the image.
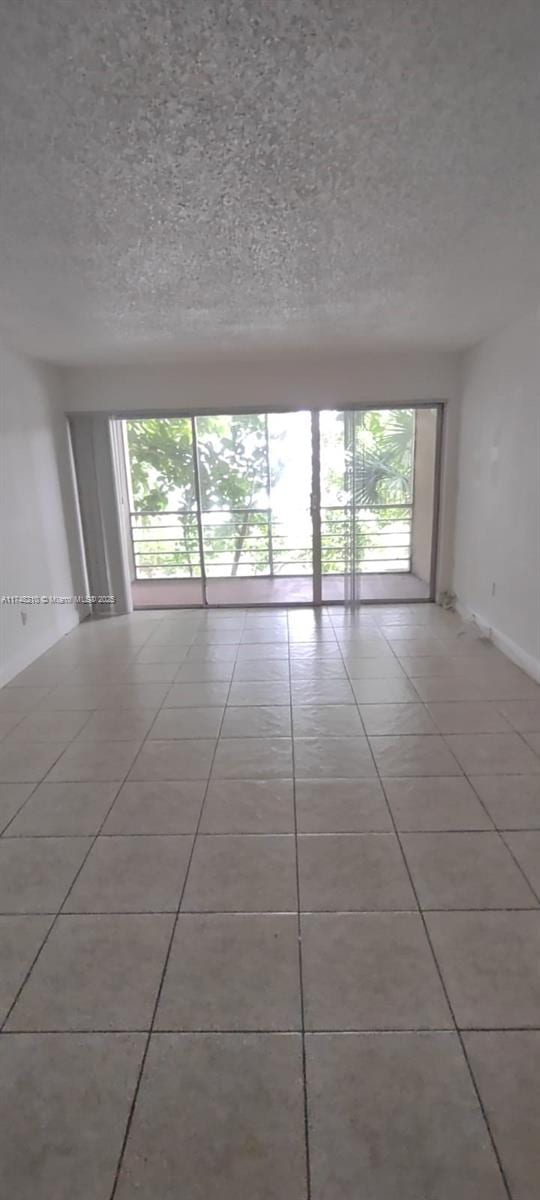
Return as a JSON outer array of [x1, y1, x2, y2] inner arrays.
[[125, 412, 313, 607]]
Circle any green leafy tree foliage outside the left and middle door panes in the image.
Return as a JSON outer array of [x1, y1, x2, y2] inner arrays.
[[126, 414, 278, 576]]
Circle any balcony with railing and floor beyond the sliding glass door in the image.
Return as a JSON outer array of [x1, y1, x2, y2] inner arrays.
[[130, 504, 428, 607]]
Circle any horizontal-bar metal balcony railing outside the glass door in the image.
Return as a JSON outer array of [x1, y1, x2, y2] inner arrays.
[[130, 504, 413, 580]]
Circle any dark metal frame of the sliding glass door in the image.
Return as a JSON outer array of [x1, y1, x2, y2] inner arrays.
[[114, 400, 446, 608]]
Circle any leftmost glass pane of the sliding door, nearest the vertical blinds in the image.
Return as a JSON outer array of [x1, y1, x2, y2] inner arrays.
[[124, 418, 203, 607]]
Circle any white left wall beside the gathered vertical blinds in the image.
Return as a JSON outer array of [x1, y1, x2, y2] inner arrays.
[[0, 348, 84, 683]]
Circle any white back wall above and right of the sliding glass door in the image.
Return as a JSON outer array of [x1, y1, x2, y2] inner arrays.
[[64, 347, 460, 592]]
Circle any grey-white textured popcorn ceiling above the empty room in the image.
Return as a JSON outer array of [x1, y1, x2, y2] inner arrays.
[[0, 0, 540, 361]]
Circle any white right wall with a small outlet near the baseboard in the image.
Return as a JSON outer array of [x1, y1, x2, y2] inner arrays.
[[454, 312, 540, 678]]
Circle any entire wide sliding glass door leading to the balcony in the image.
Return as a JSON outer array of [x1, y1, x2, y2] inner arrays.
[[124, 406, 440, 607]]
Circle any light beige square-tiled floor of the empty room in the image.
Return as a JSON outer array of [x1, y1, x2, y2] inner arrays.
[[0, 605, 540, 1200]]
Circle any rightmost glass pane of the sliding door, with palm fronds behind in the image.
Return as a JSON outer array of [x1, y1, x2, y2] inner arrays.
[[320, 407, 438, 601]]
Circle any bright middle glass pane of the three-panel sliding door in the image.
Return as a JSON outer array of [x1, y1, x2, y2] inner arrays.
[[197, 413, 313, 604]]
